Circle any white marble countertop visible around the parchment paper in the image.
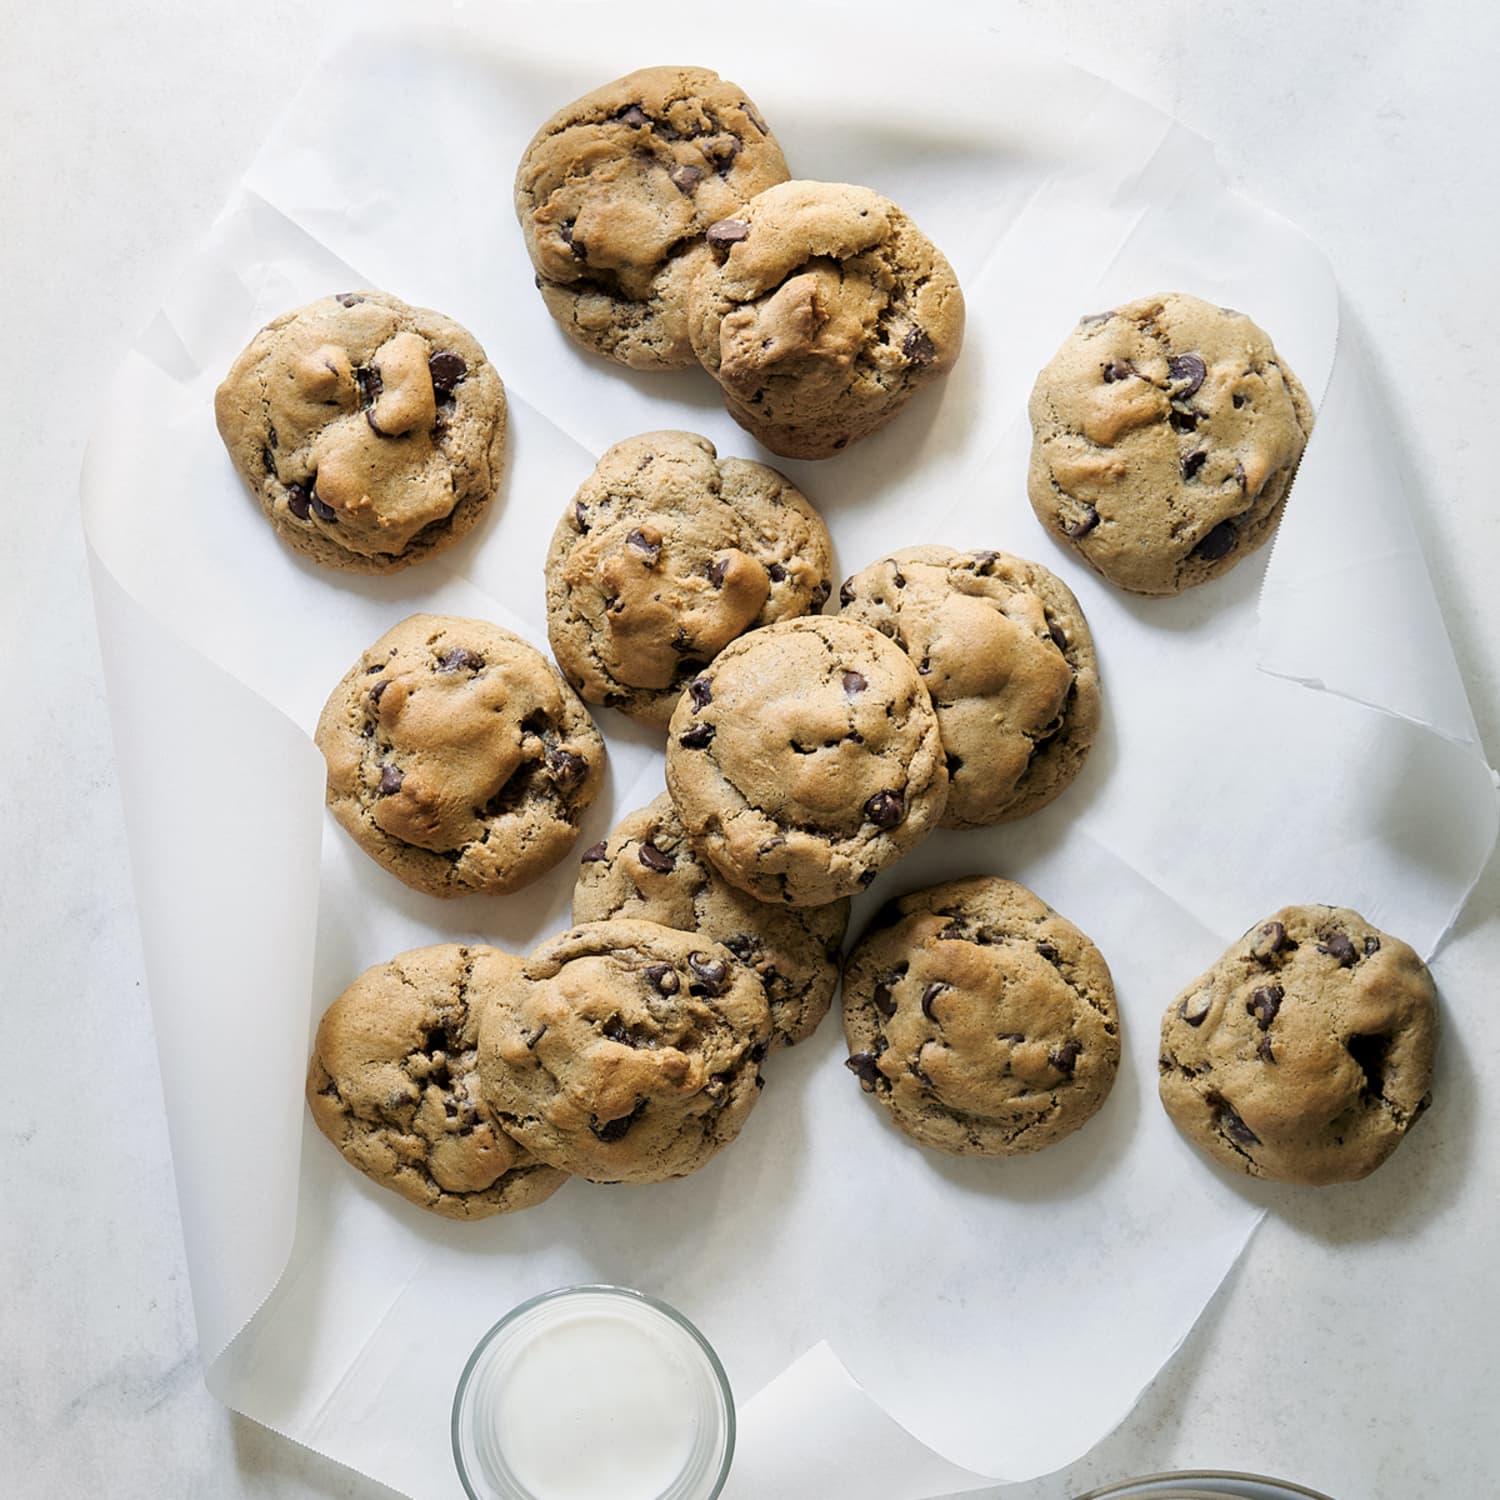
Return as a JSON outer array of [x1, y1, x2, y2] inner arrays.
[[0, 0, 1500, 1500]]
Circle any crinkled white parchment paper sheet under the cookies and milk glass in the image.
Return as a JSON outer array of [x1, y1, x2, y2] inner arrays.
[[83, 3, 1496, 1500]]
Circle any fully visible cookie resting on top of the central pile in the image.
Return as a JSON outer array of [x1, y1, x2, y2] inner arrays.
[[666, 617, 948, 906]]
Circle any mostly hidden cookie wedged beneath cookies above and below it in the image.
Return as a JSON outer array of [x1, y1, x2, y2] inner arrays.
[[573, 792, 849, 1047]]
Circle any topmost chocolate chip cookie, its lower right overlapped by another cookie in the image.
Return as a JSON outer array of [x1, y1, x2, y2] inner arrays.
[[516, 68, 786, 371]]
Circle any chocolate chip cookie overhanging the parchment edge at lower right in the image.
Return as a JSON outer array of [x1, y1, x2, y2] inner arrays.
[[1160, 906, 1437, 1185]]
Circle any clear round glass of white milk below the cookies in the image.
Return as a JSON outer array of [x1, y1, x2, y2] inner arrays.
[[453, 1287, 735, 1500]]
